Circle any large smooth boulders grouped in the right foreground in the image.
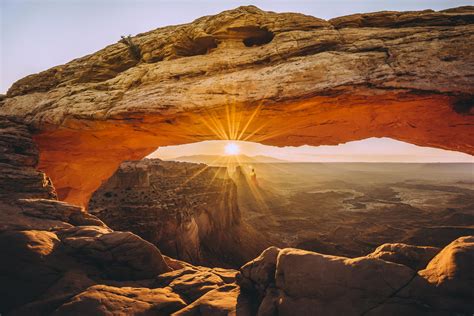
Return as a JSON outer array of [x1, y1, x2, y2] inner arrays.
[[237, 236, 474, 315]]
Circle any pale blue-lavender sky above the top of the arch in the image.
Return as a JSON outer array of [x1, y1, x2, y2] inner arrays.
[[0, 0, 473, 93]]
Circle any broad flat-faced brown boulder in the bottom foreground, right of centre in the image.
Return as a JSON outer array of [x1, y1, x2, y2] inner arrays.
[[276, 248, 415, 315]]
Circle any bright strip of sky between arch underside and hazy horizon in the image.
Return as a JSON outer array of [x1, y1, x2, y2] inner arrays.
[[149, 137, 474, 163]]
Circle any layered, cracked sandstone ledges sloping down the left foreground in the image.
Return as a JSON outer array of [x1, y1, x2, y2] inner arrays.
[[0, 120, 237, 315]]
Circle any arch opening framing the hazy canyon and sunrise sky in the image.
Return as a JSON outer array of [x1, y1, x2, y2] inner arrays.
[[88, 138, 474, 267]]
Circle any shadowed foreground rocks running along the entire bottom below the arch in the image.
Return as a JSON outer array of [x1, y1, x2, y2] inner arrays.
[[0, 121, 474, 315]]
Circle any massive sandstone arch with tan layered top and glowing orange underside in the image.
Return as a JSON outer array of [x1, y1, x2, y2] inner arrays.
[[0, 6, 474, 205]]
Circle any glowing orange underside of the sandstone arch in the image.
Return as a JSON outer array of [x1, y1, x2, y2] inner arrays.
[[34, 91, 474, 206]]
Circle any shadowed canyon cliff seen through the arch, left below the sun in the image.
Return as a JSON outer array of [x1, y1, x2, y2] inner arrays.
[[89, 159, 250, 267]]
